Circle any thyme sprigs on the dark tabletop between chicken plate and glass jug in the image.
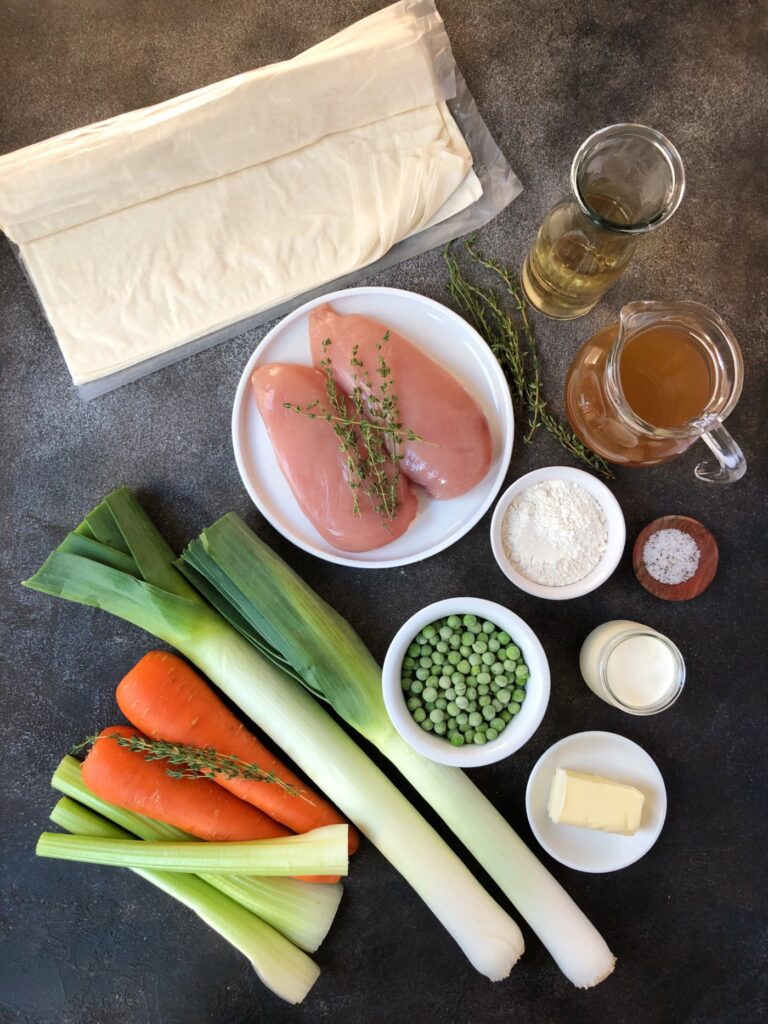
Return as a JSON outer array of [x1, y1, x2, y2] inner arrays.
[[443, 239, 613, 479]]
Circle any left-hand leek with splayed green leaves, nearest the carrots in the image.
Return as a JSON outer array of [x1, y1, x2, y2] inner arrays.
[[26, 488, 523, 980]]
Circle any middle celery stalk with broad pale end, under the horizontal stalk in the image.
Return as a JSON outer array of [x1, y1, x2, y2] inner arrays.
[[51, 756, 343, 953]]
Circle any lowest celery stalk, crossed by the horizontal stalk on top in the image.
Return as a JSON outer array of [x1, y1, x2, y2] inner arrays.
[[45, 797, 319, 1004]]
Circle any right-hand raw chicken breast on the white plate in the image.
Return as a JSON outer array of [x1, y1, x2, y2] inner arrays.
[[309, 302, 490, 498]]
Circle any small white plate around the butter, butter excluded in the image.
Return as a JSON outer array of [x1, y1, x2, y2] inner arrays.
[[525, 732, 667, 874]]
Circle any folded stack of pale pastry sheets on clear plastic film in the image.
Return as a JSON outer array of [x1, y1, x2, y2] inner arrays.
[[0, 0, 521, 398]]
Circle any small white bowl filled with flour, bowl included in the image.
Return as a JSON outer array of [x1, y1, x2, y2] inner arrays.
[[490, 466, 627, 601]]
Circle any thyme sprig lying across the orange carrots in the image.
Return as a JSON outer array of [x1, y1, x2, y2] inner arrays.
[[70, 733, 312, 804]]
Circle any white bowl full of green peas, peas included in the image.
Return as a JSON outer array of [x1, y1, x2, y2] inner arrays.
[[382, 597, 550, 768]]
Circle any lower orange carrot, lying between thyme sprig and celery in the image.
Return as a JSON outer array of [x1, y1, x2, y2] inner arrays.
[[83, 725, 291, 842]]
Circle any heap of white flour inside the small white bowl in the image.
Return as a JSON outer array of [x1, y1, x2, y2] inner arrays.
[[502, 480, 608, 587]]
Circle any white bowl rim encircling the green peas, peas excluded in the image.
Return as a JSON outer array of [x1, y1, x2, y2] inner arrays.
[[382, 597, 551, 768]]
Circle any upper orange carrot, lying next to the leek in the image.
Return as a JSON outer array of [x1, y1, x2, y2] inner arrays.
[[117, 650, 358, 853]]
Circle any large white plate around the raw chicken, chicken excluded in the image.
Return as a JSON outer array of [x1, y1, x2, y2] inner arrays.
[[232, 288, 514, 568]]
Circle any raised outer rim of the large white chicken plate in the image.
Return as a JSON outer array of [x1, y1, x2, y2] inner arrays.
[[230, 285, 515, 569]]
